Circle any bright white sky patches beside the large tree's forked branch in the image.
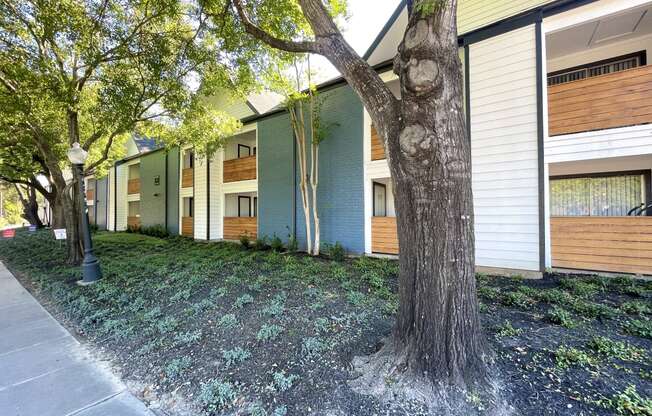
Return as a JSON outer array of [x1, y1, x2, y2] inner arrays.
[[311, 0, 400, 83]]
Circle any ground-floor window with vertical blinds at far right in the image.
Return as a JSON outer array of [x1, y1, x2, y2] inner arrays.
[[550, 172, 649, 217]]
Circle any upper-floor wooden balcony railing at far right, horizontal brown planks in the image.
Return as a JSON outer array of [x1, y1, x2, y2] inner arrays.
[[548, 65, 652, 136]]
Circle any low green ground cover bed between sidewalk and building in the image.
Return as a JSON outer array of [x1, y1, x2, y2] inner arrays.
[[0, 231, 652, 416]]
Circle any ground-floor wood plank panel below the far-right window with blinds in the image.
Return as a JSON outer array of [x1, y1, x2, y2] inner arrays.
[[550, 217, 652, 274]]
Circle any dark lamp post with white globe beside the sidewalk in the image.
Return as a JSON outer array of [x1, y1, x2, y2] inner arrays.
[[68, 142, 102, 286]]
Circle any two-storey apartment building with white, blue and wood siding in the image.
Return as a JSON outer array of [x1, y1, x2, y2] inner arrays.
[[93, 0, 652, 275]]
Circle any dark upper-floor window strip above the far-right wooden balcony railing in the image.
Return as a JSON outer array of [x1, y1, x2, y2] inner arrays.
[[548, 51, 646, 86]]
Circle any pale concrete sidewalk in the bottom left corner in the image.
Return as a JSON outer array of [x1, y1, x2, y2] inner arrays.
[[0, 262, 154, 416]]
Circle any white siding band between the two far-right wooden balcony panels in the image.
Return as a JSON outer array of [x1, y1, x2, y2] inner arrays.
[[544, 124, 652, 163]]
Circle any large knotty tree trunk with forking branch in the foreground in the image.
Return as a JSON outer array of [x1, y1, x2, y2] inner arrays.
[[234, 0, 487, 404]]
